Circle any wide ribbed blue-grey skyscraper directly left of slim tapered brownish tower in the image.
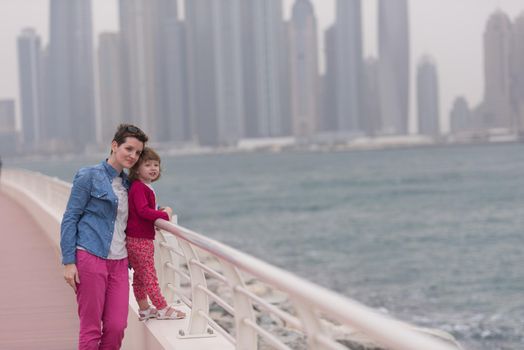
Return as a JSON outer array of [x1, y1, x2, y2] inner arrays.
[[241, 0, 288, 137]]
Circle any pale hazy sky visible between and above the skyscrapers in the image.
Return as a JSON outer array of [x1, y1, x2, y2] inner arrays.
[[0, 0, 524, 130]]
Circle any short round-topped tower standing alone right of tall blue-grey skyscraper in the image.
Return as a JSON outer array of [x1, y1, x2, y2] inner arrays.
[[417, 56, 440, 137]]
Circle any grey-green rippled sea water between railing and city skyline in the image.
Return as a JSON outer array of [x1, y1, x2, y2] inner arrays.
[[8, 144, 524, 350]]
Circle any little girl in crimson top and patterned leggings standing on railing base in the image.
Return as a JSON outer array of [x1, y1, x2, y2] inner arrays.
[[126, 147, 186, 320]]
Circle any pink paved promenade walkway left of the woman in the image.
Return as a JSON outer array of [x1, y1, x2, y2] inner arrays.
[[0, 192, 78, 350]]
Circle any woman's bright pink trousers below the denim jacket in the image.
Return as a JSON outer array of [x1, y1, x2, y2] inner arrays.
[[76, 249, 129, 350]]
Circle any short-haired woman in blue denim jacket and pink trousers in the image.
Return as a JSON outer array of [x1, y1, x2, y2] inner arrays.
[[60, 124, 148, 350]]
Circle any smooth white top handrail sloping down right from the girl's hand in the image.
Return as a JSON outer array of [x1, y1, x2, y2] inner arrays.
[[156, 220, 456, 350]]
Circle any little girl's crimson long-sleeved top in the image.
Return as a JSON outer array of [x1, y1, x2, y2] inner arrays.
[[126, 180, 169, 239]]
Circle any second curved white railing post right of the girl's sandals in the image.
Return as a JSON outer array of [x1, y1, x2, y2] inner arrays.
[[218, 259, 258, 350]]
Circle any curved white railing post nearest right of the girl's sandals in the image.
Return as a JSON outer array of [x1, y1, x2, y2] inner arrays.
[[179, 241, 209, 335]]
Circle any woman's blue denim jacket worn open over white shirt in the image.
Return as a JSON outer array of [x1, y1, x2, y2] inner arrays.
[[60, 161, 129, 265]]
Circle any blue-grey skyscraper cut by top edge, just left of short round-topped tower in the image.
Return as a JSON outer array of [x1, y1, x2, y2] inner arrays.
[[378, 0, 410, 135]]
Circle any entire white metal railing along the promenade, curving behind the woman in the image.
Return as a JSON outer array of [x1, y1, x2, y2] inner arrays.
[[2, 170, 460, 350]]
